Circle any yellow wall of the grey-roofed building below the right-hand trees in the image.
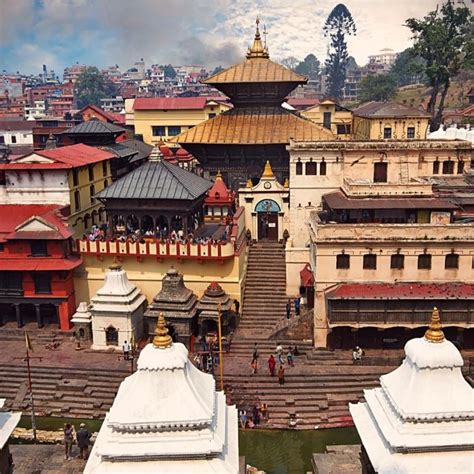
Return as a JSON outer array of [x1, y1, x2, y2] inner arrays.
[[353, 115, 429, 140]]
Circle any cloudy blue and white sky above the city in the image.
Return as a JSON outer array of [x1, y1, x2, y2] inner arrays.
[[0, 0, 437, 75]]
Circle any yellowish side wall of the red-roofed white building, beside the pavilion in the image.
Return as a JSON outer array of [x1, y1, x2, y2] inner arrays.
[[68, 160, 112, 238]]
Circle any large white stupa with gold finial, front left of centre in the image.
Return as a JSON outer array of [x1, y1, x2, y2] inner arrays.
[[84, 314, 239, 474]]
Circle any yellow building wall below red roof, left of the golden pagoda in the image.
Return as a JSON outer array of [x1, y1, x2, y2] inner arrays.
[[133, 103, 230, 145]]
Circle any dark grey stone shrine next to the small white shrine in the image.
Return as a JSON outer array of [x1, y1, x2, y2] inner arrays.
[[145, 267, 198, 345]]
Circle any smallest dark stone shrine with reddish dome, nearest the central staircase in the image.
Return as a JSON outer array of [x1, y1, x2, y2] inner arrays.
[[196, 282, 237, 336]]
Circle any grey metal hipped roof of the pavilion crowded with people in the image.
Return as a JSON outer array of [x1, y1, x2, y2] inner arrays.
[[97, 161, 213, 201]]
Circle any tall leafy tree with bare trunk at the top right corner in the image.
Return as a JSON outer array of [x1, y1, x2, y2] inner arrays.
[[406, 0, 474, 131]]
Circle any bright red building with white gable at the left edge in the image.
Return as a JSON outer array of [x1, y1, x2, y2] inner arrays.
[[0, 204, 82, 331]]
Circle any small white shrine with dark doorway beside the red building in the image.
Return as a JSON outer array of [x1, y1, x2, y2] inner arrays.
[[89, 264, 146, 349]]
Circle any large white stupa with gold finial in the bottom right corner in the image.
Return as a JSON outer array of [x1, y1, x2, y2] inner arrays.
[[349, 308, 474, 474]]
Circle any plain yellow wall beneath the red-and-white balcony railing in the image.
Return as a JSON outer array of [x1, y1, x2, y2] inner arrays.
[[74, 247, 247, 310]]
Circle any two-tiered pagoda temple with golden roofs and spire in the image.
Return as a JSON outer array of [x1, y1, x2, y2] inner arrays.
[[174, 19, 335, 191]]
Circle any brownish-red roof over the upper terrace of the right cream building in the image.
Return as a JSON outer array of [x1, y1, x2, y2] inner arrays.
[[322, 191, 457, 209]]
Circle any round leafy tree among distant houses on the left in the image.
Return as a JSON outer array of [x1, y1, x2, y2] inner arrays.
[[74, 67, 116, 109]]
